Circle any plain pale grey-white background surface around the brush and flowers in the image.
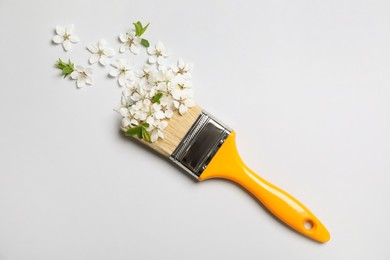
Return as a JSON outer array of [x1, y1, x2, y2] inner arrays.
[[0, 0, 390, 260]]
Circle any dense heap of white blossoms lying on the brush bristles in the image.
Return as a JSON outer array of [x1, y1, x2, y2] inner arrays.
[[118, 59, 194, 142]]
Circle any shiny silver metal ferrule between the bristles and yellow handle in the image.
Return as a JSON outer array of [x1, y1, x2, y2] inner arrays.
[[169, 111, 232, 179]]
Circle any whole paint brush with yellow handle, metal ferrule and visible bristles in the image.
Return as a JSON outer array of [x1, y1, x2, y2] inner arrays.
[[131, 106, 330, 243]]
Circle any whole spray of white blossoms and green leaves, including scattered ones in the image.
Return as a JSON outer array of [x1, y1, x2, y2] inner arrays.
[[52, 22, 194, 142]]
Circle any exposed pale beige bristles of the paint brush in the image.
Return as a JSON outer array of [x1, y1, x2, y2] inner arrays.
[[136, 106, 202, 157]]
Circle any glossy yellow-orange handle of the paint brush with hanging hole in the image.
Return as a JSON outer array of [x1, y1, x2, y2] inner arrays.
[[199, 132, 330, 242]]
